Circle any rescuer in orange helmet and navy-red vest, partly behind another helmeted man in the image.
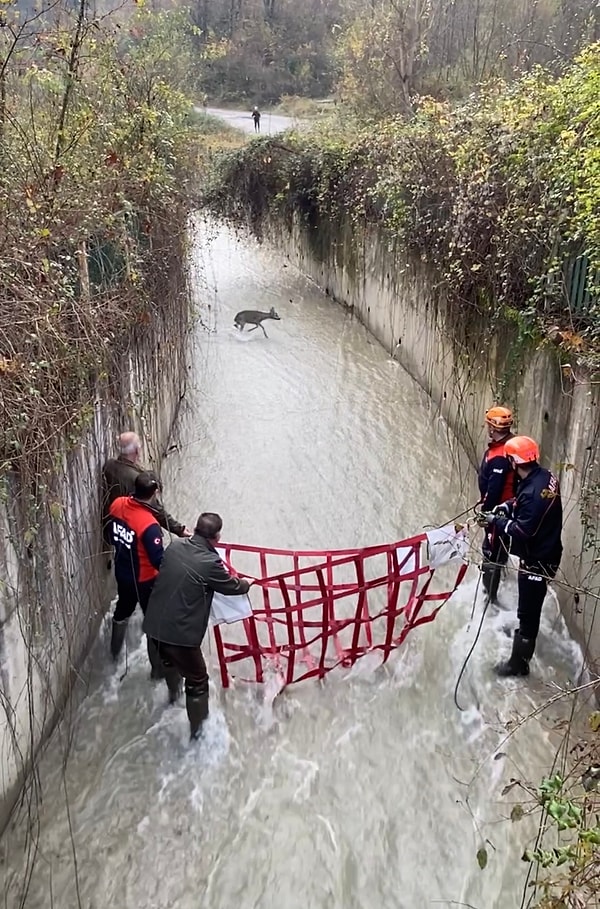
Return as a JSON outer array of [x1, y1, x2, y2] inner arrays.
[[479, 407, 516, 603]]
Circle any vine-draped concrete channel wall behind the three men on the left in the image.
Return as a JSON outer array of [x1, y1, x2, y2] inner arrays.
[[0, 310, 188, 831]]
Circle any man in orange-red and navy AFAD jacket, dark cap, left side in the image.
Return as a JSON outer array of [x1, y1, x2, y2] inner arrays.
[[109, 473, 164, 678]]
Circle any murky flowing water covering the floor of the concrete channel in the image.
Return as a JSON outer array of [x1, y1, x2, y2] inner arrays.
[[0, 222, 580, 909]]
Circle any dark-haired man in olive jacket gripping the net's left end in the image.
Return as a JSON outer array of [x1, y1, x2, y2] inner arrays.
[[142, 512, 250, 739]]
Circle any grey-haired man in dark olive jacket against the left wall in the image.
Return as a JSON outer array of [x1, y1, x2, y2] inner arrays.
[[102, 432, 191, 546]]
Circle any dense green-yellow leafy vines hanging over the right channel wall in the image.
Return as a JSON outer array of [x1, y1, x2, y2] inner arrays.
[[208, 45, 600, 362]]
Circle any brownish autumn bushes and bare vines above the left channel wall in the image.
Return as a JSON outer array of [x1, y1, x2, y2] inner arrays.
[[0, 0, 200, 472]]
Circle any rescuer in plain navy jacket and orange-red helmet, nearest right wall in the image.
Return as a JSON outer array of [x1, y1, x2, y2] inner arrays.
[[484, 436, 562, 676]]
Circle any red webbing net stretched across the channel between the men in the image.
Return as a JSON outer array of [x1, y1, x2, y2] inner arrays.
[[214, 534, 467, 688]]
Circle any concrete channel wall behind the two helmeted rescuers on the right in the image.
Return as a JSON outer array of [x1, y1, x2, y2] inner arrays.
[[282, 218, 600, 670]]
